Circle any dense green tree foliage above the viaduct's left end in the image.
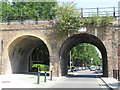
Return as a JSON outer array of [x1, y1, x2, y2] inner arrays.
[[2, 2, 57, 21]]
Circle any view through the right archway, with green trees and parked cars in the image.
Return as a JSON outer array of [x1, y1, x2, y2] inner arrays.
[[67, 43, 102, 74]]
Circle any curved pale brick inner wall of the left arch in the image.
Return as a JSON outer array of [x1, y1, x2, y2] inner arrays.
[[8, 35, 49, 73]]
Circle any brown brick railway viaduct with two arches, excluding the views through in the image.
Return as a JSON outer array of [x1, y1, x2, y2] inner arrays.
[[0, 21, 120, 77]]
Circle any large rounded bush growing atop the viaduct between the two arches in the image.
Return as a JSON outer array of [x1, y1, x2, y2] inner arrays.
[[54, 3, 82, 33]]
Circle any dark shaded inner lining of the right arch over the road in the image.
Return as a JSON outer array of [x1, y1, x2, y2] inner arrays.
[[60, 33, 108, 77]]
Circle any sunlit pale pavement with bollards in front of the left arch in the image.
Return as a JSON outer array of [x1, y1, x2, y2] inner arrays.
[[0, 74, 64, 90]]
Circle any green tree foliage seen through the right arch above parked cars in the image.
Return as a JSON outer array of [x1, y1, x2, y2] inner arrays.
[[71, 43, 101, 65]]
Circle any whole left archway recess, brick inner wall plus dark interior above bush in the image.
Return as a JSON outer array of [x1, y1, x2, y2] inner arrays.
[[8, 35, 49, 73]]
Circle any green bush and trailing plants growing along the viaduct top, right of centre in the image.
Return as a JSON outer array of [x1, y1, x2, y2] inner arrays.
[[54, 3, 113, 33]]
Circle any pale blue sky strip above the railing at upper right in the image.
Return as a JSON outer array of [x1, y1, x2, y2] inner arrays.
[[57, 0, 120, 8]]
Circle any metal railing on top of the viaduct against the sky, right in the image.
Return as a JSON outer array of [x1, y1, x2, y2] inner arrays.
[[79, 7, 120, 17]]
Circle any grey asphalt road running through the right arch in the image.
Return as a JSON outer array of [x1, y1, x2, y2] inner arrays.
[[50, 70, 106, 90]]
